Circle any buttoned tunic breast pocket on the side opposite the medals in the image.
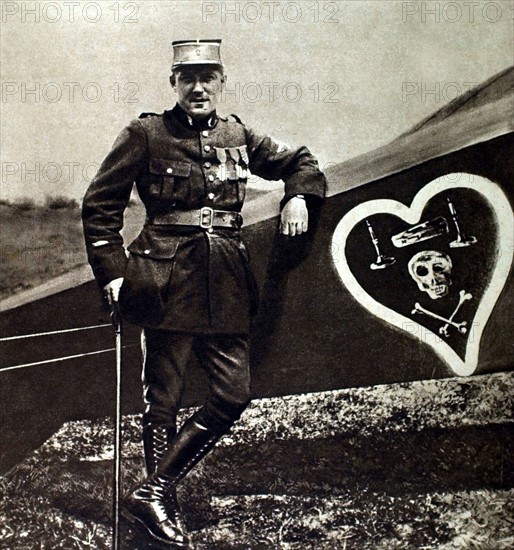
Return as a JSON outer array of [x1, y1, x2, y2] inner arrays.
[[148, 158, 191, 203]]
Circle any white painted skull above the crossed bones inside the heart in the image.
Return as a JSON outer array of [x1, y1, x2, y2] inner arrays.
[[408, 250, 452, 300]]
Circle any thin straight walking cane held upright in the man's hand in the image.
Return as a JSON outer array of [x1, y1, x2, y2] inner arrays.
[[111, 300, 121, 550]]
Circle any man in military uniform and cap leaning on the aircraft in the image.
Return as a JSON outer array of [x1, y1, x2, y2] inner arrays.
[[83, 40, 325, 547]]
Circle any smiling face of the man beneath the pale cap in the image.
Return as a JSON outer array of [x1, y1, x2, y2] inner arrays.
[[170, 65, 225, 118]]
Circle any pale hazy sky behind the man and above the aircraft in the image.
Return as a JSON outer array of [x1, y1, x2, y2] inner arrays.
[[0, 0, 514, 202]]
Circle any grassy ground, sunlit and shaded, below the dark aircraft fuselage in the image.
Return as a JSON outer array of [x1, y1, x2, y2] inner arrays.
[[0, 373, 514, 550]]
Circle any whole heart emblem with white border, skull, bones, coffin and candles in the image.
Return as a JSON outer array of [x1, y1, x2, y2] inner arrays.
[[332, 173, 514, 376]]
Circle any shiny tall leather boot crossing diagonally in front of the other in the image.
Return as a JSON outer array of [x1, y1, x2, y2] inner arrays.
[[123, 417, 223, 547]]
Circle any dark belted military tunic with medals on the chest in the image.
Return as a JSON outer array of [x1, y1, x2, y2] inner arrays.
[[83, 106, 325, 333]]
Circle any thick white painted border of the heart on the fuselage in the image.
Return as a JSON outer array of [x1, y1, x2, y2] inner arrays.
[[331, 173, 514, 376]]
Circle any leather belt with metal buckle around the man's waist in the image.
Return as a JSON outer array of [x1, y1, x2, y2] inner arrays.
[[149, 206, 243, 230]]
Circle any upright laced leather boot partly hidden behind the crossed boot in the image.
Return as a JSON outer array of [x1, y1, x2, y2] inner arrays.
[[143, 422, 187, 534]]
